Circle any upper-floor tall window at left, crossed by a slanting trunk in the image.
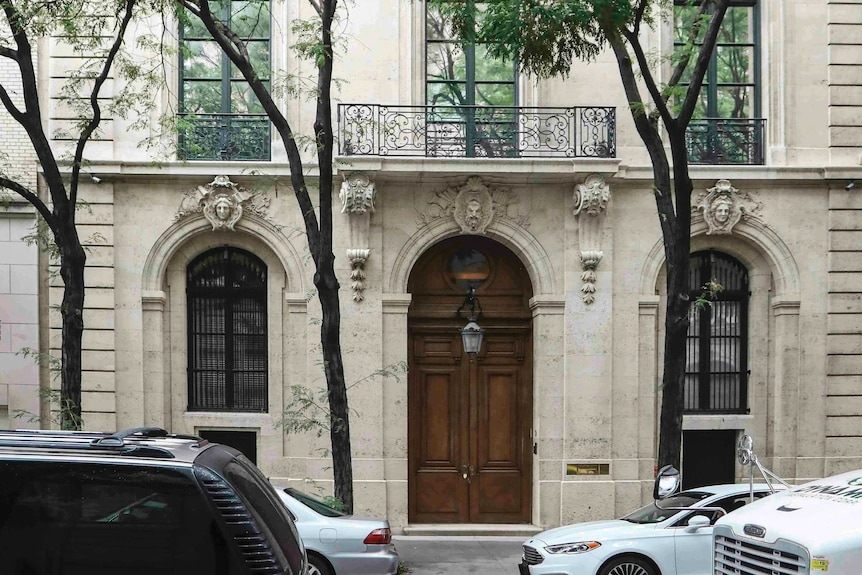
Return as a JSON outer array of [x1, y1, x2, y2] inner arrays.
[[179, 0, 270, 160]]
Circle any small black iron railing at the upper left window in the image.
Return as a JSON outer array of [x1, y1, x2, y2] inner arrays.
[[179, 114, 270, 161]]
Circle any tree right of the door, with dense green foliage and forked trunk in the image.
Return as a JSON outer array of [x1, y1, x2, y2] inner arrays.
[[428, 0, 728, 466]]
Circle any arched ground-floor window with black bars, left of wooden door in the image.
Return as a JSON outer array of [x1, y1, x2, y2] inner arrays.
[[187, 246, 268, 411]]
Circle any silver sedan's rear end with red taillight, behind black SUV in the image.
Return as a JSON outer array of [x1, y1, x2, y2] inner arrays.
[[275, 486, 398, 575]]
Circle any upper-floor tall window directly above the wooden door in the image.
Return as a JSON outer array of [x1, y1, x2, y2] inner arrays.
[[425, 0, 516, 156]]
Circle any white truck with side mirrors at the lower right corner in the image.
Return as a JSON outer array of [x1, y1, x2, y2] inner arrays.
[[656, 436, 862, 575]]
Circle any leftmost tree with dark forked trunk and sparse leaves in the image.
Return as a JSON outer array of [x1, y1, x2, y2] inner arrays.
[[0, 0, 164, 428]]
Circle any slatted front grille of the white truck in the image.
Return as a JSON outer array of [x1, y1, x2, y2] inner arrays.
[[715, 528, 809, 575]]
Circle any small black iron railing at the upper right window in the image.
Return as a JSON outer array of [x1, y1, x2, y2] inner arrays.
[[685, 118, 766, 165]]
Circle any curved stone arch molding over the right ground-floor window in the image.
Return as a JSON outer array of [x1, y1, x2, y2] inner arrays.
[[640, 219, 800, 299]]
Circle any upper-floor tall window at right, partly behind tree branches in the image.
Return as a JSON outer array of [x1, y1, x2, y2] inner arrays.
[[674, 0, 764, 164]]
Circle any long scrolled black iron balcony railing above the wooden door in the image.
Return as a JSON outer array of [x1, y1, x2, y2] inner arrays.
[[338, 104, 616, 158]]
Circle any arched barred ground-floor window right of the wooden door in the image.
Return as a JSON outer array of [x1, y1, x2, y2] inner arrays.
[[685, 250, 749, 413]]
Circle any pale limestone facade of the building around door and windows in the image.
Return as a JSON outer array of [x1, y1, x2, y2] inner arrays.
[[5, 0, 862, 531]]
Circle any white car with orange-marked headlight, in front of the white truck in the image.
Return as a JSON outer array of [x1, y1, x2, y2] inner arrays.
[[519, 483, 784, 575]]
